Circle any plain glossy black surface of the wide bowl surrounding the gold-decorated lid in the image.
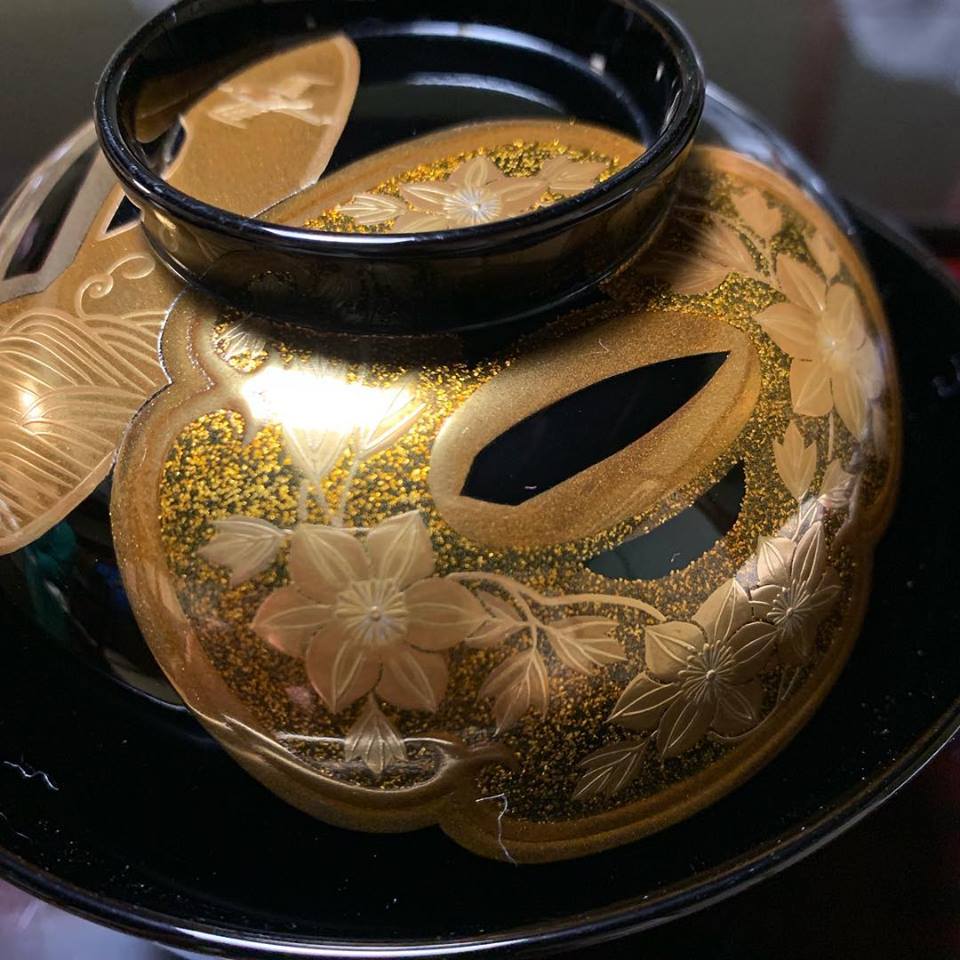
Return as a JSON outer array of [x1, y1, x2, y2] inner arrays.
[[0, 208, 960, 957]]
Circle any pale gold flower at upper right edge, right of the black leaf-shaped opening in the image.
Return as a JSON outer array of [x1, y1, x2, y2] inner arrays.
[[757, 256, 883, 440]]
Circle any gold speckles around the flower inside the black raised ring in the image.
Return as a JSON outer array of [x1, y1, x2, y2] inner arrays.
[[304, 140, 620, 233]]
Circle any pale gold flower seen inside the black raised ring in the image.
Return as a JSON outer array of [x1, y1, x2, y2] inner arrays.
[[393, 156, 546, 233]]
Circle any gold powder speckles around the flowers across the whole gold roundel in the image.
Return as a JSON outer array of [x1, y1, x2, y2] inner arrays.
[[139, 142, 896, 844]]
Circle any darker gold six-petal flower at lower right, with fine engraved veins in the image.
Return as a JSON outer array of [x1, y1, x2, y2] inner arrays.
[[610, 580, 776, 758]]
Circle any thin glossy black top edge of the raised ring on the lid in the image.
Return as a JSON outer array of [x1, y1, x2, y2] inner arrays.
[[95, 0, 706, 259]]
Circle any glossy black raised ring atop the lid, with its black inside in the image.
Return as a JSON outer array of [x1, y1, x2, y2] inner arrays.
[[96, 0, 704, 331]]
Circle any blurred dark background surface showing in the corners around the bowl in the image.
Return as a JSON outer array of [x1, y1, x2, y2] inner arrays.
[[0, 0, 960, 960]]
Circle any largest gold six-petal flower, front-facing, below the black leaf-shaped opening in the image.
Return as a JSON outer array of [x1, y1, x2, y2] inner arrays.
[[253, 511, 487, 713]]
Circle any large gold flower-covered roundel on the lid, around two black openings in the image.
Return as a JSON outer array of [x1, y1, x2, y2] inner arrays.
[[112, 148, 900, 861]]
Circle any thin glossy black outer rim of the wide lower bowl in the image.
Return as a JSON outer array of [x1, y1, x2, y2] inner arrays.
[[0, 209, 960, 960]]
